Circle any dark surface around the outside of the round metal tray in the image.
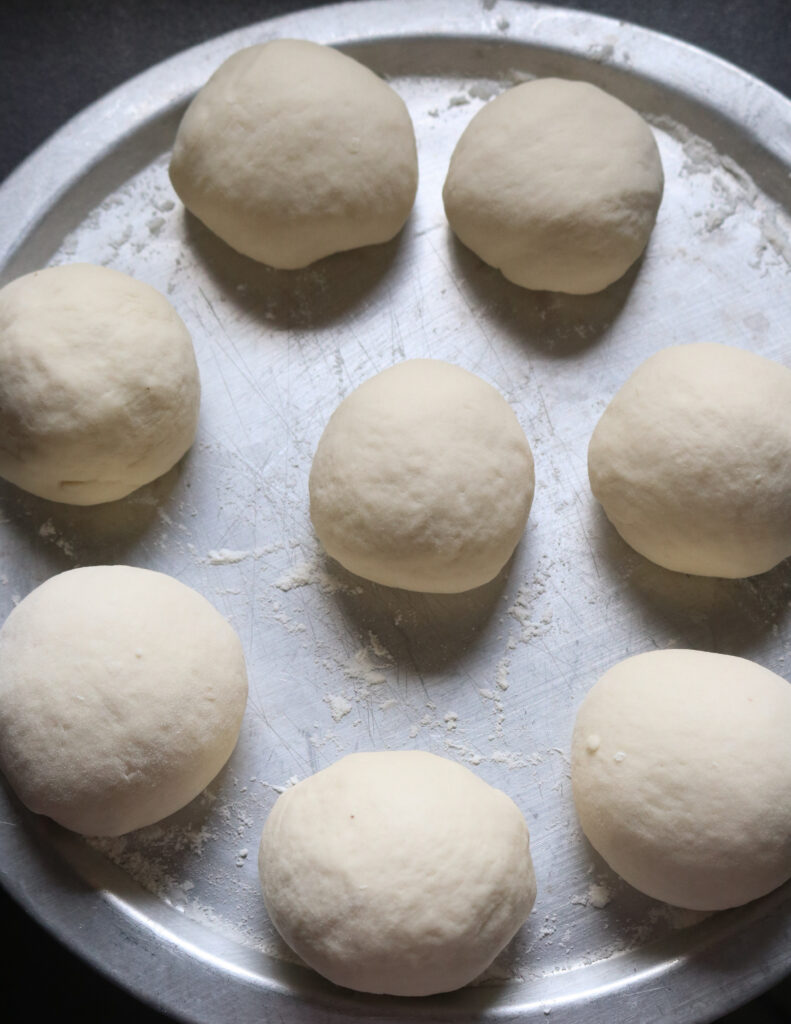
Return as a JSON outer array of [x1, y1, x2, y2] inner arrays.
[[0, 0, 791, 1024]]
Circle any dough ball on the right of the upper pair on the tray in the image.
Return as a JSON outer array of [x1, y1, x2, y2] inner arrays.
[[443, 78, 664, 295]]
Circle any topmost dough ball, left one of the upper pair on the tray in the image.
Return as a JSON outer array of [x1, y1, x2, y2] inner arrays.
[[170, 39, 417, 269]]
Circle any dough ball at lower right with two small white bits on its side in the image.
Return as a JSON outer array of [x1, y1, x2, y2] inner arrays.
[[572, 650, 791, 910]]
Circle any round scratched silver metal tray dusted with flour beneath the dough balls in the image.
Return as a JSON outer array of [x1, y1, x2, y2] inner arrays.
[[0, 0, 791, 1024]]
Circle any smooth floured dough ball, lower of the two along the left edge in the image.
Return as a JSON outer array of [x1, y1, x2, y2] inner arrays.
[[0, 565, 247, 836]]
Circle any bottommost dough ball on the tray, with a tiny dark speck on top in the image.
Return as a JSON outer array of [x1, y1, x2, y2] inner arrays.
[[258, 751, 536, 995]]
